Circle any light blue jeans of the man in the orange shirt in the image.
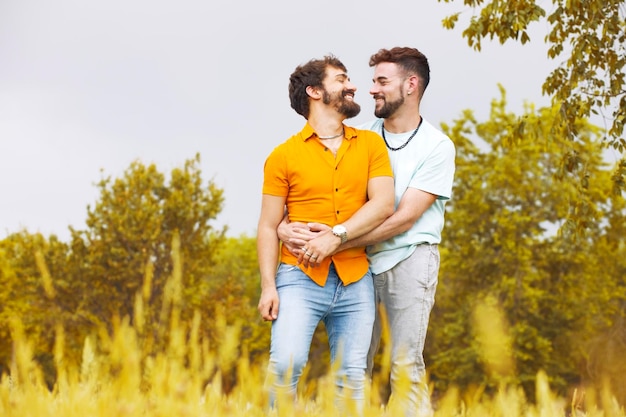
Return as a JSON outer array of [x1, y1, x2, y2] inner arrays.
[[268, 264, 375, 408]]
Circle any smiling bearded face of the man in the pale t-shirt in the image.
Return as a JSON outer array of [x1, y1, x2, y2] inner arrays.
[[370, 62, 408, 119]]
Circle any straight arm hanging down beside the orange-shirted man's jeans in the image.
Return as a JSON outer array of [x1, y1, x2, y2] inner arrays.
[[257, 194, 285, 321]]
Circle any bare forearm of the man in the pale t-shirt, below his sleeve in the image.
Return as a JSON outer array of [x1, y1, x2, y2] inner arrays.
[[339, 188, 437, 249]]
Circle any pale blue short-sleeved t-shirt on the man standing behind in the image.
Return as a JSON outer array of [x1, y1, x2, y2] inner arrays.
[[358, 119, 456, 274]]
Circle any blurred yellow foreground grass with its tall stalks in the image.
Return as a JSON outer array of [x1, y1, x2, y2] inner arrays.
[[0, 237, 626, 417]]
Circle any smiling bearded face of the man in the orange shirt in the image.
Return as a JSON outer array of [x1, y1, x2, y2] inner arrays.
[[322, 66, 361, 119]]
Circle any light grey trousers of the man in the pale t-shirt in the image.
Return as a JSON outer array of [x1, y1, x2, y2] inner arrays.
[[368, 244, 440, 417]]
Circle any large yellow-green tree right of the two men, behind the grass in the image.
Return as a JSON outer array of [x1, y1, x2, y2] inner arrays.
[[427, 89, 626, 395]]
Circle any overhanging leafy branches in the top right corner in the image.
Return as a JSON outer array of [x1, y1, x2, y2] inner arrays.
[[438, 0, 626, 228]]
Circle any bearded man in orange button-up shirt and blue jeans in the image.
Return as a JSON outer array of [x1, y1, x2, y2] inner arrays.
[[257, 56, 394, 406]]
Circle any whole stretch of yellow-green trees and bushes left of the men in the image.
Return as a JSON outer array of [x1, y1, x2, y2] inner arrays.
[[0, 156, 244, 384]]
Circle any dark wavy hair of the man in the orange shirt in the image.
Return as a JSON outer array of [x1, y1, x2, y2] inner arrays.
[[289, 55, 347, 120]]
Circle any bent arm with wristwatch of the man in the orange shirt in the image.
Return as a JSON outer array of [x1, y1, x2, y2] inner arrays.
[[298, 177, 394, 267]]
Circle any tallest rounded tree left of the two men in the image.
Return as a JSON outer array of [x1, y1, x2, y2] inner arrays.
[[70, 155, 225, 342]]
